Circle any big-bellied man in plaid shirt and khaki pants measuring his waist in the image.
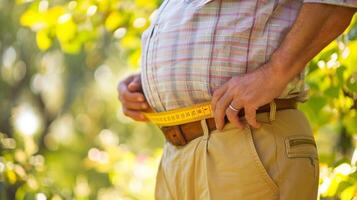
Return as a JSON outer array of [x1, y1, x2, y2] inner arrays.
[[118, 0, 357, 200]]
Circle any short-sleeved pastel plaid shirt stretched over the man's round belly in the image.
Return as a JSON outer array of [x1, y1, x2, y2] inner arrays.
[[141, 0, 357, 111]]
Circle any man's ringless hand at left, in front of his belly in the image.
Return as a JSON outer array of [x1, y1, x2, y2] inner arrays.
[[117, 74, 151, 121]]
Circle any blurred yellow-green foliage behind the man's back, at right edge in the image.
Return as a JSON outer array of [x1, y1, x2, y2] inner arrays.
[[300, 16, 357, 200]]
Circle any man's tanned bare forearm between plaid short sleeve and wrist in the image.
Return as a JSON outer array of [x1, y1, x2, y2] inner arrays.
[[271, 4, 356, 84]]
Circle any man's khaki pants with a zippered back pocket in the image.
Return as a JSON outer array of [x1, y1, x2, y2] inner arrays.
[[155, 109, 319, 200]]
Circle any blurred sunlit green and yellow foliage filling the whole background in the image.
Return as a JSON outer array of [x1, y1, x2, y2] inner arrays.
[[0, 0, 357, 200]]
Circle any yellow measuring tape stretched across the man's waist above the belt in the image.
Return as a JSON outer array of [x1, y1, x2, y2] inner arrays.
[[143, 102, 213, 126]]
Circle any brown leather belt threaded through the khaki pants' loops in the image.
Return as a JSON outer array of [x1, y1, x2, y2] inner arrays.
[[160, 99, 297, 146]]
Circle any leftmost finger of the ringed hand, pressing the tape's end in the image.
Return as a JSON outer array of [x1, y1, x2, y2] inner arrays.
[[213, 92, 232, 130]]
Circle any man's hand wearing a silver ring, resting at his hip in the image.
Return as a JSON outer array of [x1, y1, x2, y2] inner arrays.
[[212, 63, 288, 130]]
